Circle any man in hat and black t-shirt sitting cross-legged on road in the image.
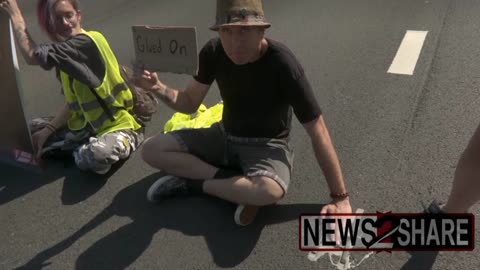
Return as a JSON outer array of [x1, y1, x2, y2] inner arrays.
[[137, 0, 351, 225]]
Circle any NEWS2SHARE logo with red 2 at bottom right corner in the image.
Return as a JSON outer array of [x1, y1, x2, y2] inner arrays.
[[299, 213, 475, 252]]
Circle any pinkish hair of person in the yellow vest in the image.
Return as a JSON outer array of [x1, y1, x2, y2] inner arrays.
[[37, 0, 80, 41]]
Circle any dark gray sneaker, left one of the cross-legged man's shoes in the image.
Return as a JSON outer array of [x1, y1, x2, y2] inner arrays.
[[147, 175, 190, 203]]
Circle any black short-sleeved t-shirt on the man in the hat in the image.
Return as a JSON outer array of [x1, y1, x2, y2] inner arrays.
[[194, 38, 321, 138]]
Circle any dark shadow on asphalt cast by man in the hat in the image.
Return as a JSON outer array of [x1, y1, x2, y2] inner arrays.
[[12, 173, 323, 269]]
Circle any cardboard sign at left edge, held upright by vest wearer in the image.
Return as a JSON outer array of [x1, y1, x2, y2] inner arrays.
[[0, 12, 35, 170]]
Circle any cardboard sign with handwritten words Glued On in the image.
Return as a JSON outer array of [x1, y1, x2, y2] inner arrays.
[[132, 26, 198, 75]]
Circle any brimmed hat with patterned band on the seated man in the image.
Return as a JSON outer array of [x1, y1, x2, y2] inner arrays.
[[210, 0, 271, 31]]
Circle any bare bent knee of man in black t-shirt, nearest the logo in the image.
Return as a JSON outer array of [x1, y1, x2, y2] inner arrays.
[[252, 176, 285, 205]]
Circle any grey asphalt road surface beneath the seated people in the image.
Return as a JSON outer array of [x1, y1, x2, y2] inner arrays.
[[0, 0, 480, 269]]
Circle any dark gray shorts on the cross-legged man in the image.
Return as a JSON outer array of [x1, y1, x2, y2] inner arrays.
[[169, 123, 293, 193]]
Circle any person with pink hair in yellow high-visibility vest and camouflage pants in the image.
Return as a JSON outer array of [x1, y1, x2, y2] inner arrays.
[[0, 0, 144, 174]]
